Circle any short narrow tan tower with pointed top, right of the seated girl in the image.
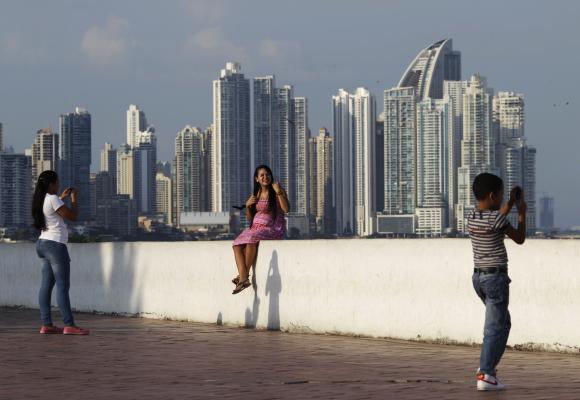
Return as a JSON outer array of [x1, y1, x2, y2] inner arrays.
[[309, 128, 336, 234]]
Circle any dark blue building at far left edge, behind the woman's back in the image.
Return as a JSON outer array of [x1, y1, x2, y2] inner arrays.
[[0, 152, 32, 227]]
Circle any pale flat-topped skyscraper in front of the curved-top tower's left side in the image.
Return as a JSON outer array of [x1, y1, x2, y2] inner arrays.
[[384, 87, 417, 216]]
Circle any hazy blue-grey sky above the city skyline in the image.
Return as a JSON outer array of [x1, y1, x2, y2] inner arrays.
[[0, 0, 580, 226]]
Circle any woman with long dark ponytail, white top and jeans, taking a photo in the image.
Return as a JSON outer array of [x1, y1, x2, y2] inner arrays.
[[32, 171, 89, 335]]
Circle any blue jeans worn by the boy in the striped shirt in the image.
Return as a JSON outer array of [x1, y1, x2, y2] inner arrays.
[[473, 272, 512, 376]]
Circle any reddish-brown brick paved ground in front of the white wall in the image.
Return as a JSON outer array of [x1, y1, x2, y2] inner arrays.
[[0, 308, 580, 400]]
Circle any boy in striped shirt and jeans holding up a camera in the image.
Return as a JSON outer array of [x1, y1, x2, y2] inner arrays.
[[468, 173, 526, 391]]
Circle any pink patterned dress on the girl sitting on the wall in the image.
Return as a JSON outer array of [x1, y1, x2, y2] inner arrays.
[[234, 199, 286, 246]]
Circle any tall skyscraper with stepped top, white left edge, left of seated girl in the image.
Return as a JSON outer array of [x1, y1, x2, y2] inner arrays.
[[211, 63, 252, 212]]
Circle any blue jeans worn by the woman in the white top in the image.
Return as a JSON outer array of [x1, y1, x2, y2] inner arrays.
[[36, 239, 74, 326]]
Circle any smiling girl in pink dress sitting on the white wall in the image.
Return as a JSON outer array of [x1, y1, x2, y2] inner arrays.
[[232, 165, 290, 294]]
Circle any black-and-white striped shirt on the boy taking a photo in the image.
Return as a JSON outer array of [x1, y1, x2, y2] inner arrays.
[[467, 210, 510, 268]]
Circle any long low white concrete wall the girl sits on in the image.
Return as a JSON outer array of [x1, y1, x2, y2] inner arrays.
[[0, 239, 580, 352]]
